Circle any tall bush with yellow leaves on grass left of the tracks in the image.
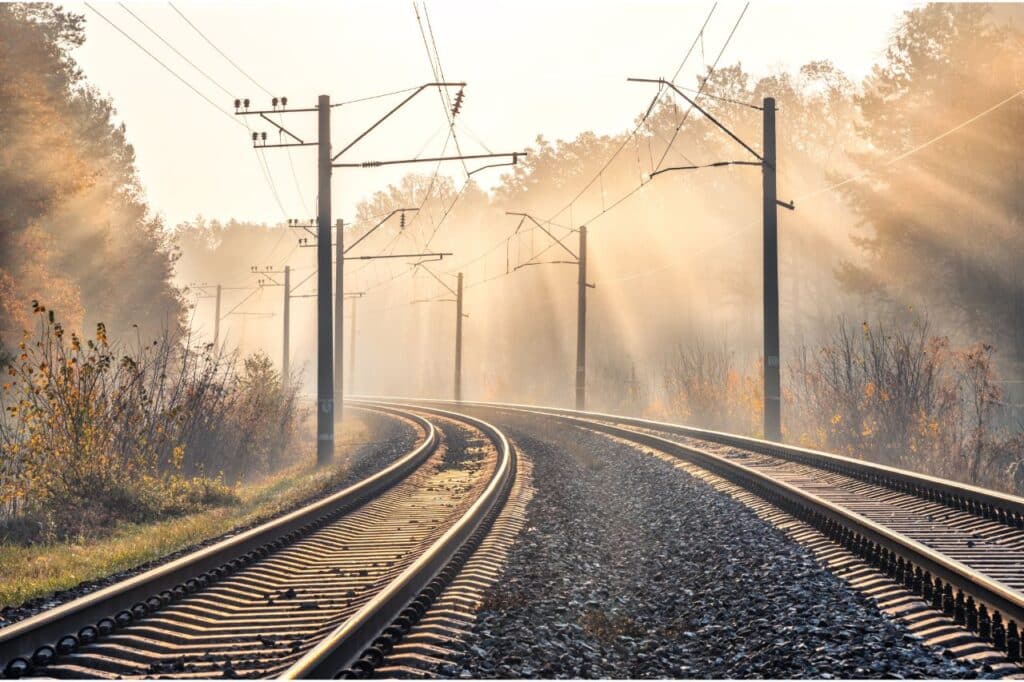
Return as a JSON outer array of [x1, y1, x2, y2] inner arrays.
[[0, 302, 297, 542]]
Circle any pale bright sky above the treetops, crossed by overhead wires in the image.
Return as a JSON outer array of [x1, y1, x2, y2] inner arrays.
[[68, 0, 920, 229]]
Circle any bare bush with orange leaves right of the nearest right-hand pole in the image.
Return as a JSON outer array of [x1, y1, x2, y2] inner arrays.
[[784, 319, 1024, 492]]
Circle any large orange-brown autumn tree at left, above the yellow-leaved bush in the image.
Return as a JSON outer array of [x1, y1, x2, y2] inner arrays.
[[0, 3, 183, 344]]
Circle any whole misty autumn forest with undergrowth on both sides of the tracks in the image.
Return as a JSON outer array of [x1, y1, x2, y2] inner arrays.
[[0, 4, 1024, 540]]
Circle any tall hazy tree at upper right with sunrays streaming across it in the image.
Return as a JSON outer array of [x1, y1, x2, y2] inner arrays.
[[841, 4, 1024, 358]]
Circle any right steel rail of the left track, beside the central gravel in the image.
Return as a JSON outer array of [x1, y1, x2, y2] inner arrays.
[[280, 400, 515, 680]]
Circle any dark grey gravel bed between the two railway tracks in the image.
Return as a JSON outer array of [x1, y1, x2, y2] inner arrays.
[[438, 413, 985, 679]]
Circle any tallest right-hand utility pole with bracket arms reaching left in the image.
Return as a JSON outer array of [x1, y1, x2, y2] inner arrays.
[[627, 78, 797, 440]]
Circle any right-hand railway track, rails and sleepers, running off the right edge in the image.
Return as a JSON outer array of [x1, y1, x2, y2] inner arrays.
[[415, 395, 1024, 664]]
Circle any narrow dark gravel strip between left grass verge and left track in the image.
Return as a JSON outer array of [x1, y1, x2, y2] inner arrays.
[[0, 405, 421, 628]]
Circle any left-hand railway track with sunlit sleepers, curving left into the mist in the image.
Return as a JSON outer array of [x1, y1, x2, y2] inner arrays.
[[0, 402, 515, 678]]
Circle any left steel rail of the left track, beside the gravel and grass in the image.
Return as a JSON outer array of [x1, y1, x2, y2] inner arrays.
[[0, 404, 439, 677]]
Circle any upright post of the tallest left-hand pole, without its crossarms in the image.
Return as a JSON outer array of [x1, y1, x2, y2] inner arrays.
[[316, 95, 341, 466]]
